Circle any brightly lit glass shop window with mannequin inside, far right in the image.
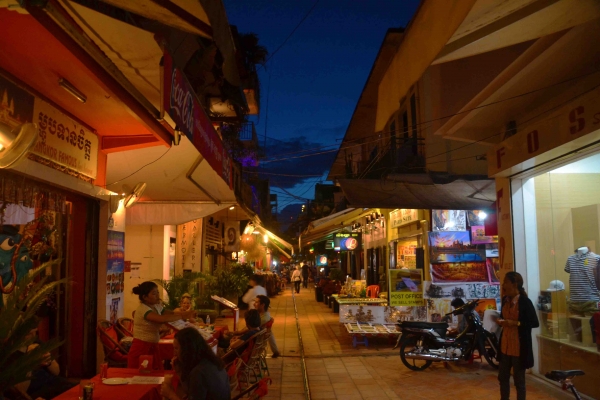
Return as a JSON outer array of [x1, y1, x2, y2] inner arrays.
[[512, 154, 600, 398]]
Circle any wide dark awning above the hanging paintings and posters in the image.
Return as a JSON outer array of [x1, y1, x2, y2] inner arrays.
[[338, 174, 496, 210]]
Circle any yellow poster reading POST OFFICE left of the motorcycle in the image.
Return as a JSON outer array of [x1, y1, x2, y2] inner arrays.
[[388, 269, 423, 306]]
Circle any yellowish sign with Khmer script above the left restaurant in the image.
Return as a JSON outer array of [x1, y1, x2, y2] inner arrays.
[[0, 76, 98, 179]]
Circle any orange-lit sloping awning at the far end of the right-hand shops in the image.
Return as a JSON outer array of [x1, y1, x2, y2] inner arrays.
[[300, 208, 372, 247]]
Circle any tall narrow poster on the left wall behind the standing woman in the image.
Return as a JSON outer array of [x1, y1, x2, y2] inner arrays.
[[106, 231, 125, 323]]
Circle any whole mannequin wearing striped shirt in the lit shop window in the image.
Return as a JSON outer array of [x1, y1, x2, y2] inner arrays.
[[565, 246, 600, 316]]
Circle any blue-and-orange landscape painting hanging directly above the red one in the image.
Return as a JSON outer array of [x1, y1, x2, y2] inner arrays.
[[429, 231, 485, 264]]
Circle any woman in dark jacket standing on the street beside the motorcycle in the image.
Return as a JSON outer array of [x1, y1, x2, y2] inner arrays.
[[498, 271, 540, 400]]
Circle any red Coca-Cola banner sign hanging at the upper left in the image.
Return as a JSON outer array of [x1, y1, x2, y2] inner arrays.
[[163, 51, 233, 188]]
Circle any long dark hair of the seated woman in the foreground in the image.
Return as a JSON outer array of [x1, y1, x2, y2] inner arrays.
[[175, 328, 225, 382]]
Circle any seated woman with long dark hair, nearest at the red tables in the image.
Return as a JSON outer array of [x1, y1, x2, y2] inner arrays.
[[161, 328, 230, 400]]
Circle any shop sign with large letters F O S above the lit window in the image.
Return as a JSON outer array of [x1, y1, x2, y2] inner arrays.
[[487, 88, 600, 176]]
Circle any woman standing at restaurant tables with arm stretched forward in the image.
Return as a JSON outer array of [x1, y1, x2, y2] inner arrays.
[[127, 282, 195, 370]]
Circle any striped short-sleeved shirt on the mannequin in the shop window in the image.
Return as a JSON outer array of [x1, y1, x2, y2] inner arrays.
[[565, 251, 600, 303]]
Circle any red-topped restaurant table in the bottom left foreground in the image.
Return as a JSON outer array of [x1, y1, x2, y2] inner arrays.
[[54, 368, 165, 400]]
